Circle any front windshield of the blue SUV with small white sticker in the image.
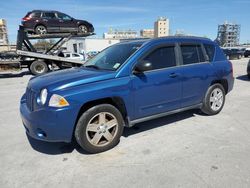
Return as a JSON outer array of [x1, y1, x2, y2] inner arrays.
[[83, 43, 141, 71]]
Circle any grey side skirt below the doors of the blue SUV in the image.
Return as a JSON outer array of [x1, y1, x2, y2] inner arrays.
[[128, 103, 202, 127]]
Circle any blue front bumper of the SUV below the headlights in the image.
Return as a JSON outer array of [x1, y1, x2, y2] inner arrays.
[[20, 95, 77, 143]]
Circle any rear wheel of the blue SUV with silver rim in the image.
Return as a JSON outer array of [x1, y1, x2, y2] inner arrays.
[[201, 84, 225, 115]]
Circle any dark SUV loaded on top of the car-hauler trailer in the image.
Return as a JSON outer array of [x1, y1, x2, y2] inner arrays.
[[22, 10, 94, 34]]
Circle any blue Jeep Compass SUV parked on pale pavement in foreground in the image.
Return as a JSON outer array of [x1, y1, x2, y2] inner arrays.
[[20, 37, 234, 153]]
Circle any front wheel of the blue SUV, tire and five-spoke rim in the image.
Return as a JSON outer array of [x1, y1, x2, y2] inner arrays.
[[75, 104, 124, 153]]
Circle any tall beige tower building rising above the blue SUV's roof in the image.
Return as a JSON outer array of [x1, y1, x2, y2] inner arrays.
[[154, 17, 170, 38]]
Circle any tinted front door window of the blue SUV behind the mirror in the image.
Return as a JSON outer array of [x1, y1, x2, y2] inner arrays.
[[144, 46, 176, 70]]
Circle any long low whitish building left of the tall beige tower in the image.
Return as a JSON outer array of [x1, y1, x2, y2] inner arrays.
[[103, 29, 138, 39]]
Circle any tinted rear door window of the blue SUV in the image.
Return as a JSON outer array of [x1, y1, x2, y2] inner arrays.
[[181, 44, 205, 65]]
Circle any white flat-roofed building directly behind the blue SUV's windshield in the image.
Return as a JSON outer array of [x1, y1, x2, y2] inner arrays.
[[63, 37, 120, 54]]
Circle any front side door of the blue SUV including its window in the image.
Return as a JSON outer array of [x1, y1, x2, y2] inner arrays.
[[131, 45, 181, 119]]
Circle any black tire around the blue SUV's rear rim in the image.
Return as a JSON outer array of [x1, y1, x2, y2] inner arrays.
[[201, 84, 225, 115]]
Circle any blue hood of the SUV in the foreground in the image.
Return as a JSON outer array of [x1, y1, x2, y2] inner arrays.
[[28, 67, 115, 91]]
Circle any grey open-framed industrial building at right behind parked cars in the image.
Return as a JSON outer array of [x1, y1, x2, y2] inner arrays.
[[217, 22, 240, 47]]
